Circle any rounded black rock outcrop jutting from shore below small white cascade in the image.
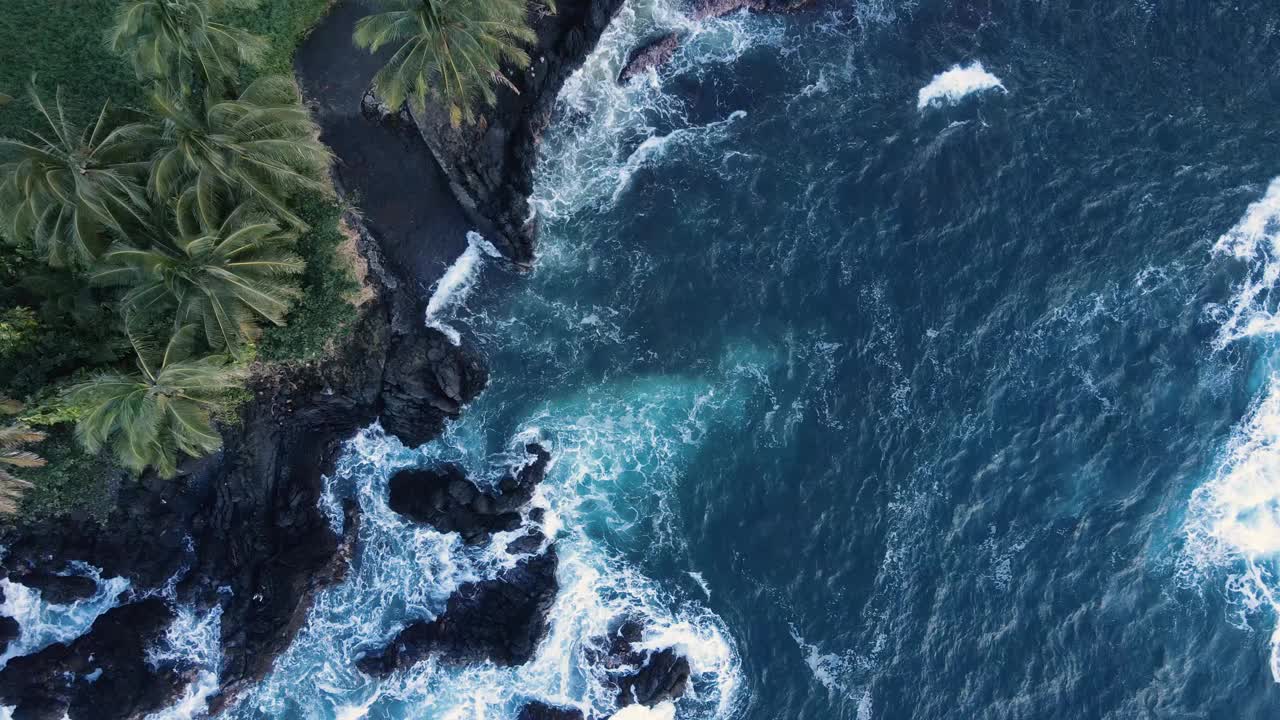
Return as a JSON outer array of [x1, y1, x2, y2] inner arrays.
[[381, 328, 489, 447]]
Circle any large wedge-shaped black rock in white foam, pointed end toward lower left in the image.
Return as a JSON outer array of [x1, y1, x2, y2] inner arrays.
[[357, 547, 559, 676]]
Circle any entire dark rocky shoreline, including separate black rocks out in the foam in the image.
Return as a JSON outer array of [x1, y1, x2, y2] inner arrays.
[[0, 0, 773, 707]]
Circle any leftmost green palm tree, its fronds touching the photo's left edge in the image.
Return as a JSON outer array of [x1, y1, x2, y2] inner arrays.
[[0, 86, 150, 266]]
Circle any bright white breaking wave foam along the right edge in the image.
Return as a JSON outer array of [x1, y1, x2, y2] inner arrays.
[[1180, 178, 1280, 683]]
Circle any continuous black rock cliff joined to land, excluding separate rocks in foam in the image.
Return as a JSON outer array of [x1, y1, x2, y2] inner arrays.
[[0, 0, 621, 707]]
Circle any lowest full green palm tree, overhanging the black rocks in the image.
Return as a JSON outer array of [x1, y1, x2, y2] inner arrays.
[[69, 325, 243, 478]]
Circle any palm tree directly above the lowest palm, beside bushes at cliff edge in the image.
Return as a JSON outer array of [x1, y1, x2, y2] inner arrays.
[[92, 190, 305, 351]]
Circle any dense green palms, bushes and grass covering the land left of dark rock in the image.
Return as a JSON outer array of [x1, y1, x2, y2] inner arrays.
[[0, 0, 358, 515]]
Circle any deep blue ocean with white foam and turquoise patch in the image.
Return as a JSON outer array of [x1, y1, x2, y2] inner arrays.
[[147, 0, 1280, 720]]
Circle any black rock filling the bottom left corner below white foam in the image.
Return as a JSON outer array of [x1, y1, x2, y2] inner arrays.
[[0, 598, 184, 720]]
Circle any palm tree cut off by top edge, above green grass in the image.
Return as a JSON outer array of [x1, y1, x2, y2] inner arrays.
[[108, 0, 268, 96]]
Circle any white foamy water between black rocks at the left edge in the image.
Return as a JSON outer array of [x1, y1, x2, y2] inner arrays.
[[0, 562, 129, 667]]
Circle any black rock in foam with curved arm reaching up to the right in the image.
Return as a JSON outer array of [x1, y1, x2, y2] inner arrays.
[[388, 443, 550, 540]]
